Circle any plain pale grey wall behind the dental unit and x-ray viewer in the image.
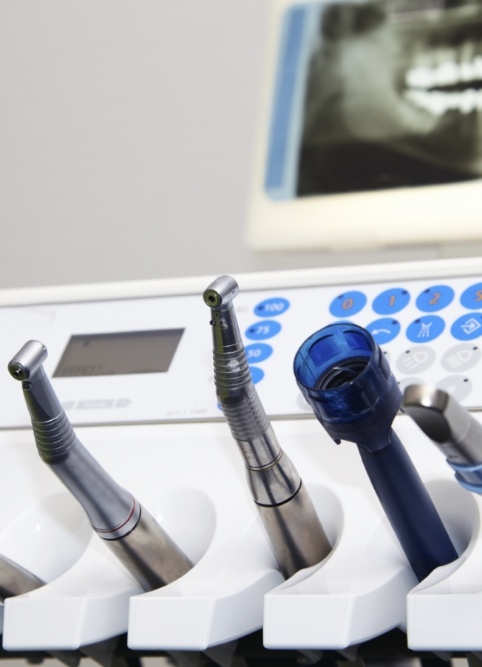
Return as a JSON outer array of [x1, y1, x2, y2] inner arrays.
[[0, 0, 482, 288]]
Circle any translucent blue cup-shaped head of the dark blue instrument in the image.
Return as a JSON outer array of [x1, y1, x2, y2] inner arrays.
[[294, 322, 402, 449]]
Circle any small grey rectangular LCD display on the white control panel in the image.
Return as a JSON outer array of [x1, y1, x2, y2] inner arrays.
[[54, 329, 184, 377]]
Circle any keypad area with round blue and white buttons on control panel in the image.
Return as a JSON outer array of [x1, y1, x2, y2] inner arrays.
[[240, 277, 482, 407]]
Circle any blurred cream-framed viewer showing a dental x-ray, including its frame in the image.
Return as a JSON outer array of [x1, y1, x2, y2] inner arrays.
[[247, 0, 482, 250]]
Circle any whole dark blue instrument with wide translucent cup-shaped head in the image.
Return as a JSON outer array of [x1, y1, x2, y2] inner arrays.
[[294, 322, 457, 581]]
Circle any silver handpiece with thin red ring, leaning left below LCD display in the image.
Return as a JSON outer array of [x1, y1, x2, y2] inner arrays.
[[8, 341, 192, 591]]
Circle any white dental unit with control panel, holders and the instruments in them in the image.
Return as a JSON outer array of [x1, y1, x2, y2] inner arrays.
[[0, 259, 482, 652]]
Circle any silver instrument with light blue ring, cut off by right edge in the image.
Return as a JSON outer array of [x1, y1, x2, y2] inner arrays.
[[402, 384, 482, 493]]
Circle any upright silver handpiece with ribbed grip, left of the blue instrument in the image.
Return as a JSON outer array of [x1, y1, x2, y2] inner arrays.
[[203, 276, 330, 577]]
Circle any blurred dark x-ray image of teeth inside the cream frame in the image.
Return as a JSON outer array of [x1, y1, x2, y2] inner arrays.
[[267, 0, 482, 198]]
